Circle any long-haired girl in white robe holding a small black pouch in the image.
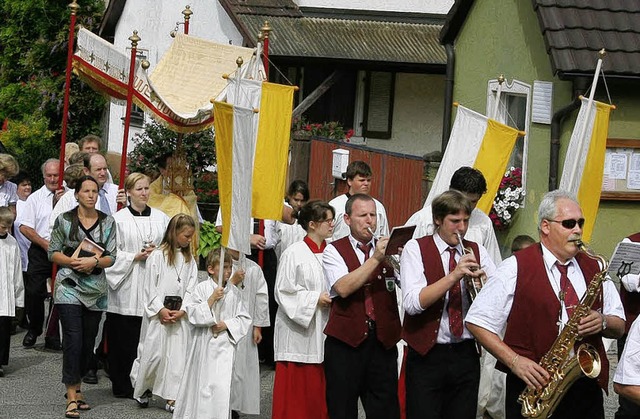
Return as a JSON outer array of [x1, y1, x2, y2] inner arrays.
[[131, 214, 198, 412]]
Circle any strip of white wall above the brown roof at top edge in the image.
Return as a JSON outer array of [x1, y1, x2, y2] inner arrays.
[[295, 0, 453, 14]]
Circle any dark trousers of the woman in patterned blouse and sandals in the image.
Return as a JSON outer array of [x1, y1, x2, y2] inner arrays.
[[56, 304, 102, 385]]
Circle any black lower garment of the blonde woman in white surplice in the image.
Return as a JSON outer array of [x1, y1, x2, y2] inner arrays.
[[105, 313, 142, 397]]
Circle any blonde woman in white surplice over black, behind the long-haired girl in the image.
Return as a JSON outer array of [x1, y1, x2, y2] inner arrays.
[[105, 173, 169, 398]]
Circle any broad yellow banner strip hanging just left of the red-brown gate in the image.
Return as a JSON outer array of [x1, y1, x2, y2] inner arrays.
[[252, 82, 294, 220]]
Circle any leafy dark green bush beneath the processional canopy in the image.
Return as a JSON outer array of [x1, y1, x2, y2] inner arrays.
[[127, 122, 218, 180]]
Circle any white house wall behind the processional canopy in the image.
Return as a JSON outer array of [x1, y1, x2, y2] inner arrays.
[[105, 0, 242, 152]]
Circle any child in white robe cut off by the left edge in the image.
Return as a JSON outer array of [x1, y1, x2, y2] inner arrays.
[[0, 207, 24, 377]]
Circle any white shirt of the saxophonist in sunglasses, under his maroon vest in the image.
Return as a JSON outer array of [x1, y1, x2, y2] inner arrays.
[[465, 245, 625, 336]]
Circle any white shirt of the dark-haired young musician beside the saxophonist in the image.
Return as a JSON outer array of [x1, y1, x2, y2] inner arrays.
[[400, 234, 496, 343]]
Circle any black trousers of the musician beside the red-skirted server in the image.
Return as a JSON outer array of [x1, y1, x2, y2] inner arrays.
[[324, 330, 400, 419]]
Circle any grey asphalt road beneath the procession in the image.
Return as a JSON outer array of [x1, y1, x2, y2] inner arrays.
[[0, 332, 618, 419]]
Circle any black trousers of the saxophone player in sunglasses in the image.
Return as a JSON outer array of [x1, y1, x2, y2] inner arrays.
[[505, 373, 604, 419]]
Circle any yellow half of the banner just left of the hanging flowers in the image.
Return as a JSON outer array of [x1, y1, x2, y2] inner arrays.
[[473, 119, 519, 214]]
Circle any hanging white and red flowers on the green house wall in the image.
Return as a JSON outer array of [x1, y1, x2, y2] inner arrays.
[[489, 167, 525, 230]]
